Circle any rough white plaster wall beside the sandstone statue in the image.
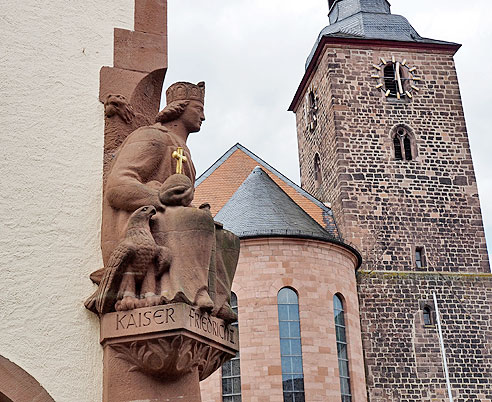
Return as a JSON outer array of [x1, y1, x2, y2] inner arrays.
[[0, 0, 134, 402]]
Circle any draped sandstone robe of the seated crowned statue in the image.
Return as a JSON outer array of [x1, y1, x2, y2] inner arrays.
[[101, 123, 239, 321]]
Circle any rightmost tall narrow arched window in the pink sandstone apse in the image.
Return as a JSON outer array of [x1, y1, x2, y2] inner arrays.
[[333, 295, 352, 402]]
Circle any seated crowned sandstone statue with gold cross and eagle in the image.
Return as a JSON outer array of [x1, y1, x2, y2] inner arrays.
[[86, 82, 239, 322]]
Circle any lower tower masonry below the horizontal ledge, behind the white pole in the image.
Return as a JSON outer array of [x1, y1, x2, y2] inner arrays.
[[358, 271, 492, 402]]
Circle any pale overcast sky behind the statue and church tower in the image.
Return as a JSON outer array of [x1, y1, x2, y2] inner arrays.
[[164, 0, 492, 260]]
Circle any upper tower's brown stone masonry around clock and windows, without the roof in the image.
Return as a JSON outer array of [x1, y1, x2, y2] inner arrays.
[[296, 45, 489, 272]]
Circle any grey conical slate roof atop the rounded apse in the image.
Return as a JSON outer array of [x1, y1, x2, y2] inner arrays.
[[215, 167, 333, 240]]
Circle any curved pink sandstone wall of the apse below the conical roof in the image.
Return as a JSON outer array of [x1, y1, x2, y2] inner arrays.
[[202, 238, 366, 402]]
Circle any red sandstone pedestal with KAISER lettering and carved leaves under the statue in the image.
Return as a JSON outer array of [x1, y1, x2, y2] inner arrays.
[[101, 303, 239, 402]]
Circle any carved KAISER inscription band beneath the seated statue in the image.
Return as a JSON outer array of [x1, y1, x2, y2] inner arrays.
[[101, 303, 239, 350]]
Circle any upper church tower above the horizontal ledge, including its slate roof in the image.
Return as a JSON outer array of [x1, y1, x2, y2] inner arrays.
[[291, 0, 489, 272]]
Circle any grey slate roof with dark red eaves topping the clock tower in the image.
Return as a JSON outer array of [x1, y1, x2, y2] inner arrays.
[[306, 0, 457, 68]]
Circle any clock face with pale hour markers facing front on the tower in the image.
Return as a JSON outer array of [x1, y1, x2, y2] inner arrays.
[[371, 56, 421, 99]]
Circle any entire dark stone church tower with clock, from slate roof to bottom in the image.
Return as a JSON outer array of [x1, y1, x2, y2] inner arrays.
[[289, 0, 492, 402]]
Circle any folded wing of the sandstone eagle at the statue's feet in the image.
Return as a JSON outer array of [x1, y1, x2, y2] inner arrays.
[[85, 240, 136, 314]]
